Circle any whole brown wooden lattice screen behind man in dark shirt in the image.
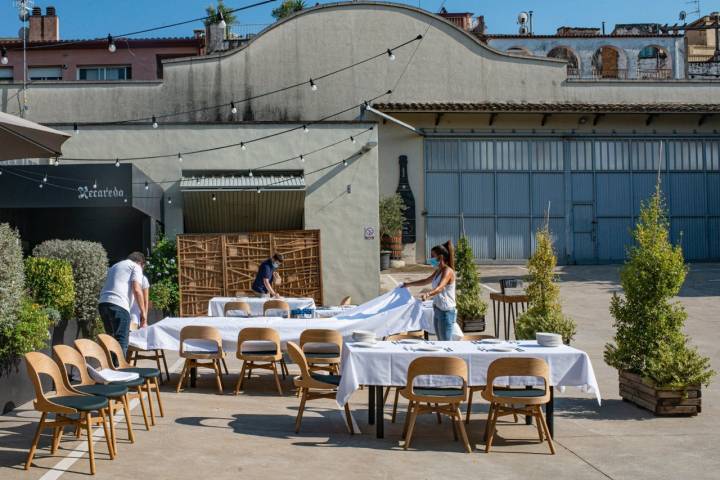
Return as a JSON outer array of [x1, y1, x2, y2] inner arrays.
[[177, 230, 322, 317]]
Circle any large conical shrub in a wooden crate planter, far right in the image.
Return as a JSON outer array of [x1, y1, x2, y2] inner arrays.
[[605, 184, 715, 415]]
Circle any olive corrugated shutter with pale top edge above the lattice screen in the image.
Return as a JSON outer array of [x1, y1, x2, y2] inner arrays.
[[180, 174, 305, 233]]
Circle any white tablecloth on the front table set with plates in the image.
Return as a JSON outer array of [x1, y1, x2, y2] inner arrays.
[[337, 341, 601, 406]]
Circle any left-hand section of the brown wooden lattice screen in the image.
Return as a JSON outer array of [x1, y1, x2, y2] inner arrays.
[[177, 235, 224, 317]]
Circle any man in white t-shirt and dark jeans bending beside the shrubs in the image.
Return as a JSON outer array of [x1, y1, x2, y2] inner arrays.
[[98, 252, 147, 353]]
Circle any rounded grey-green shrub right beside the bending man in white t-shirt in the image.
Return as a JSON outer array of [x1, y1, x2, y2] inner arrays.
[[33, 240, 108, 338]]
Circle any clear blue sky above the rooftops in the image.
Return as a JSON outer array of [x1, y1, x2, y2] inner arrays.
[[0, 0, 708, 39]]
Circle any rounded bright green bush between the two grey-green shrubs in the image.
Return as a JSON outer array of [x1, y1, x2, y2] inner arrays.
[[25, 257, 75, 320]]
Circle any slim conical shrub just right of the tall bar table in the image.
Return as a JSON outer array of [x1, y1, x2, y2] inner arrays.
[[515, 222, 577, 343]]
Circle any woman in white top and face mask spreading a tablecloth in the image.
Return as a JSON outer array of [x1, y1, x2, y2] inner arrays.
[[403, 240, 457, 340]]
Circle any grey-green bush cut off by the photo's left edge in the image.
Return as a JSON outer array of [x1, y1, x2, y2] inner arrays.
[[0, 223, 25, 332]]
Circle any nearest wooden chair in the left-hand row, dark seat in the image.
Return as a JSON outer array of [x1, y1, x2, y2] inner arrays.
[[25, 352, 115, 475]]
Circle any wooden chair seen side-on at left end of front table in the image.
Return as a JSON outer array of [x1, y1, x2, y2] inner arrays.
[[287, 342, 355, 435]]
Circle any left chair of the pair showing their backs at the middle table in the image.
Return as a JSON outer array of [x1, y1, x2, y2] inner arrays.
[[176, 325, 225, 395]]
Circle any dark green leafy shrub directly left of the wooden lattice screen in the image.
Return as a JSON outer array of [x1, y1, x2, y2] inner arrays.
[[144, 236, 180, 315]]
